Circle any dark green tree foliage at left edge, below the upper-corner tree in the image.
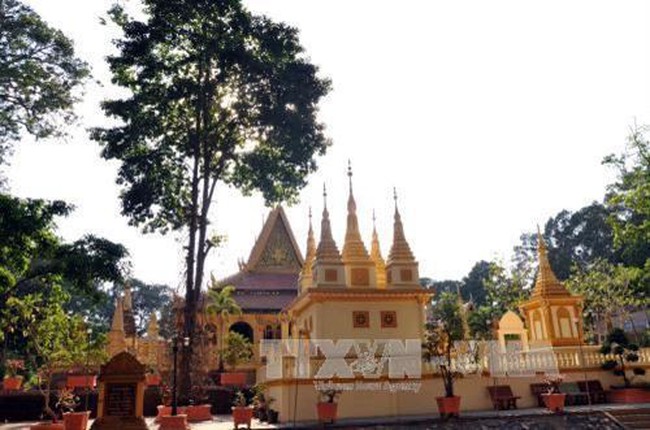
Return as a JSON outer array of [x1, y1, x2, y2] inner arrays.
[[0, 194, 128, 360]]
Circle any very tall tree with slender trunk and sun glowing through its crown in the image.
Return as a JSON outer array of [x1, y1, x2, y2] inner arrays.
[[92, 0, 330, 393]]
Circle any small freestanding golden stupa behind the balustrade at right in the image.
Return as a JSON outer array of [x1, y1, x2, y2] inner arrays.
[[519, 227, 583, 347]]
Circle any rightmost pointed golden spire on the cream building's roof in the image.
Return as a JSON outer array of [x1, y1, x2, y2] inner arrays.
[[386, 189, 421, 288]]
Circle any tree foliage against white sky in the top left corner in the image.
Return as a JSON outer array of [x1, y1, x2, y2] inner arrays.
[[0, 0, 89, 163]]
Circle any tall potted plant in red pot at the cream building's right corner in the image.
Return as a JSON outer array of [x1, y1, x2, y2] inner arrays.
[[422, 293, 464, 419]]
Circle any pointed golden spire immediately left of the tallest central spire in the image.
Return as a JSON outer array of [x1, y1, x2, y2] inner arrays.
[[312, 185, 346, 287]]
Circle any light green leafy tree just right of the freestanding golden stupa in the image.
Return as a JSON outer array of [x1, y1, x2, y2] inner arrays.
[[566, 259, 647, 342]]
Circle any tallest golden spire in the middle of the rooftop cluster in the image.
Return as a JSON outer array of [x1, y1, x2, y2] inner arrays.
[[342, 160, 377, 288]]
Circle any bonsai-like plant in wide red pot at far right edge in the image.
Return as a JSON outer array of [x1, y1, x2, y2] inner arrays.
[[600, 328, 650, 403]]
